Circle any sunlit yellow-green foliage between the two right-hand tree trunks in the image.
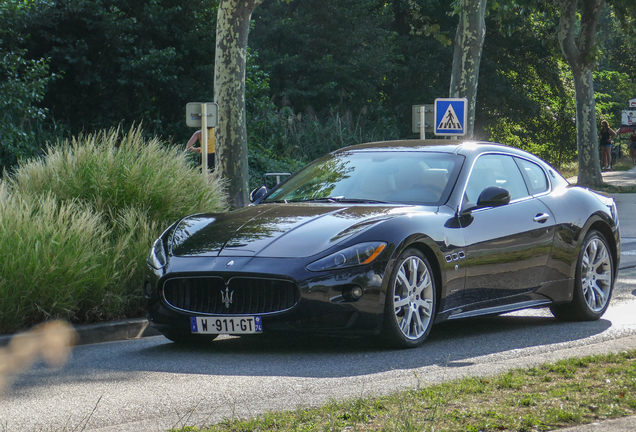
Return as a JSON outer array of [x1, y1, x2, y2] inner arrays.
[[476, 6, 577, 166]]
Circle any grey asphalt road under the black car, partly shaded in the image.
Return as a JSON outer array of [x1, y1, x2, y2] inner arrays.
[[0, 190, 636, 432]]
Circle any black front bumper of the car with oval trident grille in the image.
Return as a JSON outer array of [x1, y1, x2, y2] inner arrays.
[[144, 257, 386, 335]]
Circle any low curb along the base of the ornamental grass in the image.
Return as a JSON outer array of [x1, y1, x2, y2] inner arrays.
[[0, 318, 161, 347]]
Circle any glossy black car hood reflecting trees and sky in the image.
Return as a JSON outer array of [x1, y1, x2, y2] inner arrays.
[[170, 204, 412, 258]]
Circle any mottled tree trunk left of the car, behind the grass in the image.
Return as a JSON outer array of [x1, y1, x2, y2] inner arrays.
[[214, 0, 262, 208]]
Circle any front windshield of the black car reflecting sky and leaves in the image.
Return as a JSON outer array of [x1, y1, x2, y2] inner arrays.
[[264, 151, 464, 205]]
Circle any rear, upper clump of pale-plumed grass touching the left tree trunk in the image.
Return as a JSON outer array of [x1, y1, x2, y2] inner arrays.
[[9, 128, 226, 223]]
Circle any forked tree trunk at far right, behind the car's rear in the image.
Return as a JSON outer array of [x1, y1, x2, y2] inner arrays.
[[559, 0, 605, 187]]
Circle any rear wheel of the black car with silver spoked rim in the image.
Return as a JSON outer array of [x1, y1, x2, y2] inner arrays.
[[550, 230, 614, 321]]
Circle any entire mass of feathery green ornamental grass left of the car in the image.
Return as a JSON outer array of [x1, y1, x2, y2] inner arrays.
[[0, 128, 227, 333]]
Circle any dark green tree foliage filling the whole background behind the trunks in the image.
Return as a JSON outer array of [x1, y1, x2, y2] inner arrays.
[[0, 0, 636, 181]]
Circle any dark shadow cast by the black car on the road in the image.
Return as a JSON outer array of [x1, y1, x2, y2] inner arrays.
[[57, 316, 612, 377]]
